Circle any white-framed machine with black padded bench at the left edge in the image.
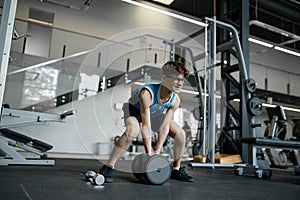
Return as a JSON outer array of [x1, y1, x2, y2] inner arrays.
[[0, 106, 75, 165]]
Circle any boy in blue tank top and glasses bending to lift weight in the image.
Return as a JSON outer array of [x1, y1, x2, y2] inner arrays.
[[100, 61, 193, 183]]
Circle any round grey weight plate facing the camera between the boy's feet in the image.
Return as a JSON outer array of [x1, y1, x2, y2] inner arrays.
[[146, 155, 171, 185]]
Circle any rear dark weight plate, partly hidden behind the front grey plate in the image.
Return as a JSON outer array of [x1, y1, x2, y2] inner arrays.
[[131, 153, 148, 183]]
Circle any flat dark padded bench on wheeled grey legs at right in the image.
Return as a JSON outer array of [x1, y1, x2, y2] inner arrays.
[[235, 137, 300, 178]]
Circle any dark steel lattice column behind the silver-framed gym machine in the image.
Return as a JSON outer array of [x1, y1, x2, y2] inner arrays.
[[217, 0, 253, 162]]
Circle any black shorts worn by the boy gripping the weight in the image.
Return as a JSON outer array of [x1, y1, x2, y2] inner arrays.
[[122, 103, 165, 133]]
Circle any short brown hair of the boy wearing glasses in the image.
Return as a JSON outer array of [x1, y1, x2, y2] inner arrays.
[[162, 61, 189, 77]]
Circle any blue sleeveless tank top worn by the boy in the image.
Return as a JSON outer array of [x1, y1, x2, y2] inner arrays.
[[129, 82, 177, 118]]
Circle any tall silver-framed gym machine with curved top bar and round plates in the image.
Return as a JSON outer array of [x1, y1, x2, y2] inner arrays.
[[189, 18, 262, 168]]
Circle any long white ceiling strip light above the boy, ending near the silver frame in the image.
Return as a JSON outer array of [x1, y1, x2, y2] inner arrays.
[[122, 0, 207, 26]]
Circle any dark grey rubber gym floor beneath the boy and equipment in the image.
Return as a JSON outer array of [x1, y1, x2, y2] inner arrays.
[[0, 159, 300, 200]]
